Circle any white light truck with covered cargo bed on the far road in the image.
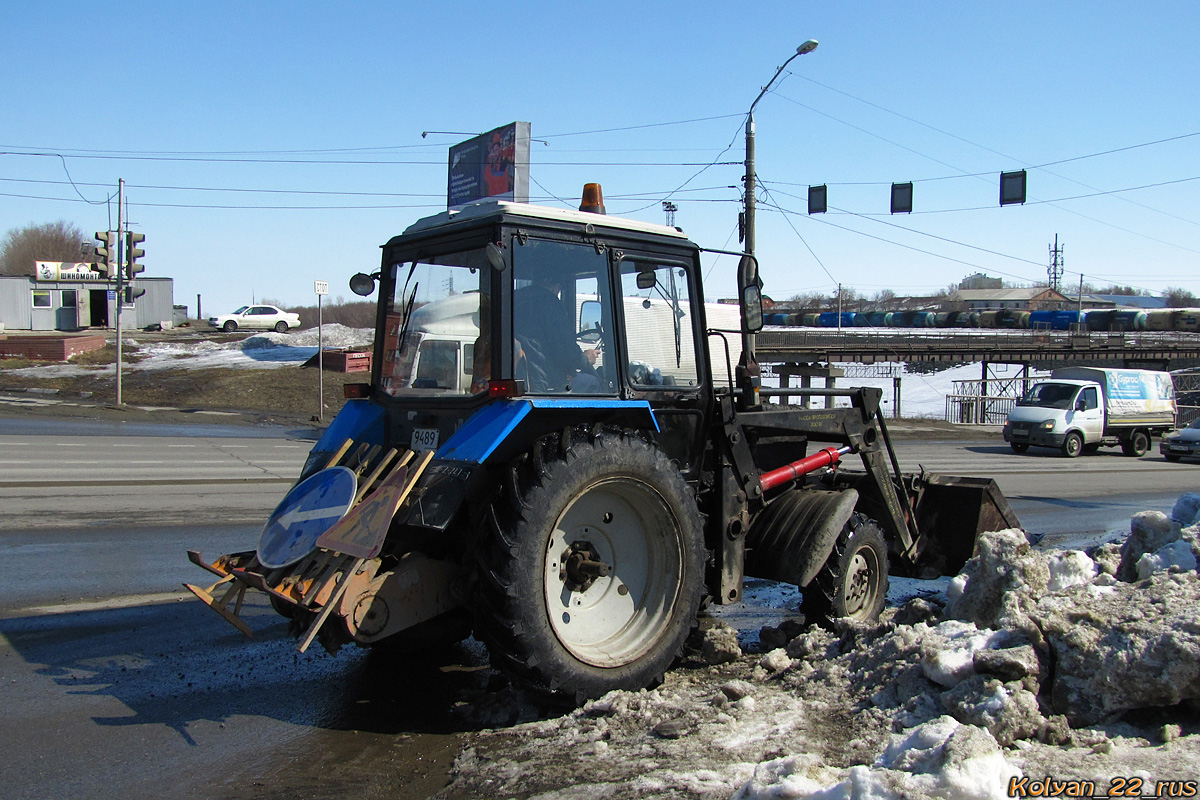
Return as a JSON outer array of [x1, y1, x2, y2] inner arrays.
[[1004, 367, 1176, 458]]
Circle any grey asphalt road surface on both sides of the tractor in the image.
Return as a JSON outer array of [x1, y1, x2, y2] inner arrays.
[[0, 422, 1200, 800]]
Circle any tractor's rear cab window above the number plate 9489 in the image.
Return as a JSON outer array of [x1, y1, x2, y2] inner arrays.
[[380, 248, 491, 397]]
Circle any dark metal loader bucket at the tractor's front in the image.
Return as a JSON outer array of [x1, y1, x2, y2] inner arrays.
[[914, 474, 1021, 576]]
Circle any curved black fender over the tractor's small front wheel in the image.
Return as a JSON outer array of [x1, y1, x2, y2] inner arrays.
[[745, 489, 858, 588]]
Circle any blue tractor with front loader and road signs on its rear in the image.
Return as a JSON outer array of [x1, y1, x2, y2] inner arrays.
[[190, 185, 1018, 702]]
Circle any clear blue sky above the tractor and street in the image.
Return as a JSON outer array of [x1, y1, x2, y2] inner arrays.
[[0, 0, 1200, 314]]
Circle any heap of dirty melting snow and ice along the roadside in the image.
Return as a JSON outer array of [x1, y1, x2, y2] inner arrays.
[[436, 495, 1200, 800]]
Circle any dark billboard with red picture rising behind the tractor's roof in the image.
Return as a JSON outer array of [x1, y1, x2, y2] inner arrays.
[[446, 122, 529, 209]]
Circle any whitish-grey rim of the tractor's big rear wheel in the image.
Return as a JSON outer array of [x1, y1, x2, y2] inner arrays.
[[544, 477, 683, 667]]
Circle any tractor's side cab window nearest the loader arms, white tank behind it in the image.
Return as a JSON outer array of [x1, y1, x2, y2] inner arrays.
[[620, 260, 700, 389]]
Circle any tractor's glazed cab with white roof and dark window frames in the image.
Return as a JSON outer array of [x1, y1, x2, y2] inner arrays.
[[310, 195, 724, 489]]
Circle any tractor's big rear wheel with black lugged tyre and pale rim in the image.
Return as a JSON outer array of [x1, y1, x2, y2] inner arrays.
[[475, 433, 706, 703]]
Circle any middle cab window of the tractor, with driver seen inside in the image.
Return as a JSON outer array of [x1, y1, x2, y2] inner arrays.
[[512, 239, 617, 395]]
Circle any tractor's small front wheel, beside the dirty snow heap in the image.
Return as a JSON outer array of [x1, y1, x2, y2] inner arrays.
[[800, 513, 888, 622]]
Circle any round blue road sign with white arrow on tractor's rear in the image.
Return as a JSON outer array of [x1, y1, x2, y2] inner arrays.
[[258, 467, 359, 570]]
